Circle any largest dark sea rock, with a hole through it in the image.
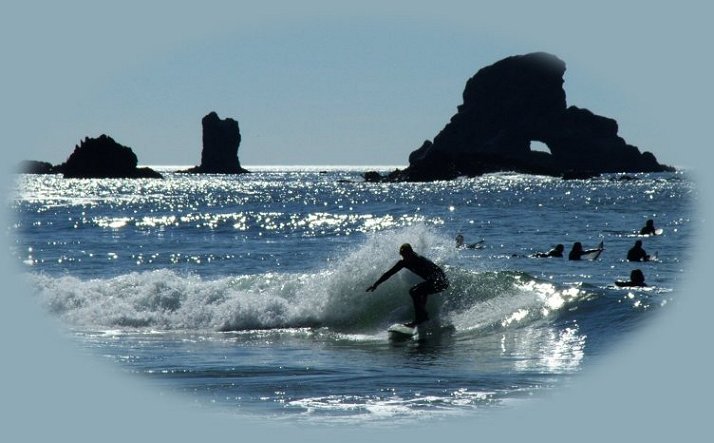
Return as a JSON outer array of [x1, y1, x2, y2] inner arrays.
[[366, 52, 673, 181]]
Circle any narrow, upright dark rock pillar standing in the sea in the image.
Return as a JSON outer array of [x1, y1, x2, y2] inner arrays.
[[185, 112, 248, 174]]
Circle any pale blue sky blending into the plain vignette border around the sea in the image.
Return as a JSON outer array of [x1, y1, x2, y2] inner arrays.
[[0, 0, 714, 442]]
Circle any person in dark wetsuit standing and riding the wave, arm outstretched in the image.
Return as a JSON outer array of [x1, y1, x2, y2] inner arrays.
[[367, 243, 449, 328]]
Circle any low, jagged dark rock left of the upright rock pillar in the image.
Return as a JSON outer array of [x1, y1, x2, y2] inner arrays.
[[53, 134, 162, 178]]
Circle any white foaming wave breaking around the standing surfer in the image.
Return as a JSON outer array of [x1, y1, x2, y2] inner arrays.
[[30, 226, 616, 340]]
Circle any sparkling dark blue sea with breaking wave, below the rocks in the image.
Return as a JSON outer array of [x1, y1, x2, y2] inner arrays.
[[8, 167, 698, 425]]
